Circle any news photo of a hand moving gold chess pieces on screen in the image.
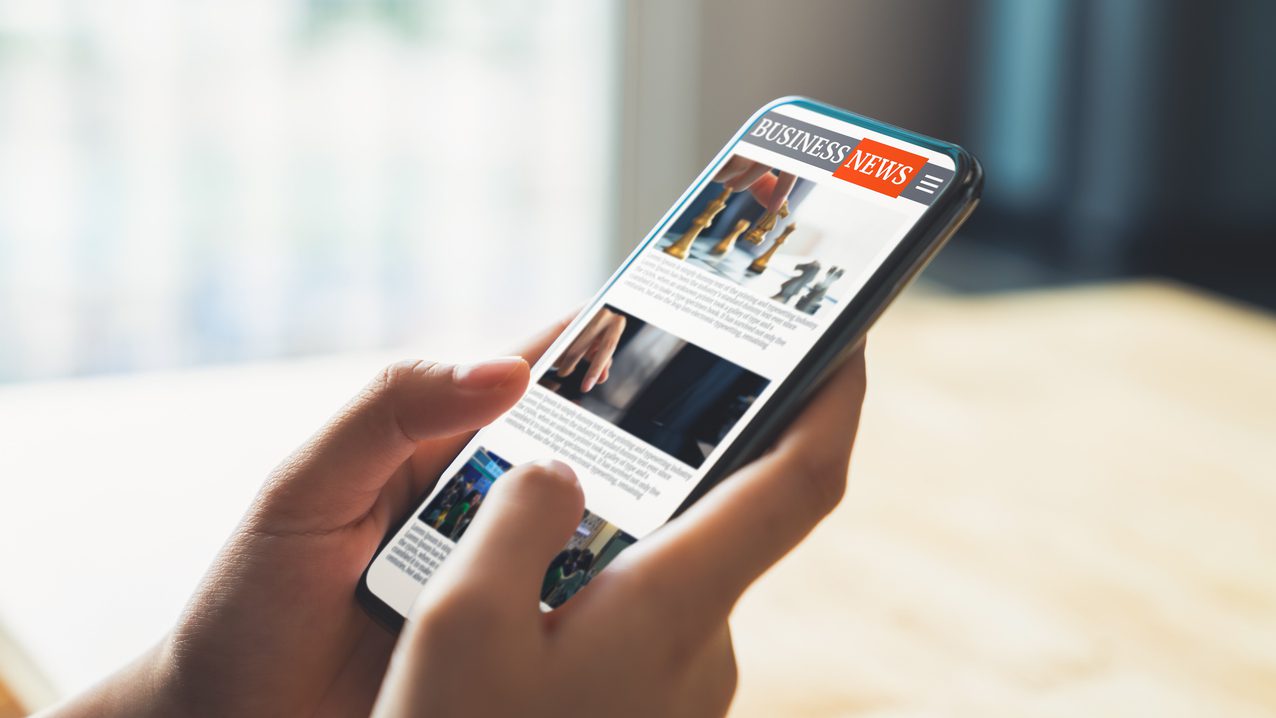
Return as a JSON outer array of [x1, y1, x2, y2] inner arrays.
[[656, 154, 898, 315]]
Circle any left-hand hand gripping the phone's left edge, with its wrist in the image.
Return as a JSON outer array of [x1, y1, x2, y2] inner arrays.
[[48, 323, 565, 717]]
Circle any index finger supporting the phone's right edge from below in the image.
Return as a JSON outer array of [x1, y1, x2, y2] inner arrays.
[[622, 348, 865, 630]]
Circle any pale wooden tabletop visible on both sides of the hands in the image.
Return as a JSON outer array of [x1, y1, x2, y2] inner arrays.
[[0, 284, 1276, 718]]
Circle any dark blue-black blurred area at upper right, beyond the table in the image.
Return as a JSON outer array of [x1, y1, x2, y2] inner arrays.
[[966, 0, 1276, 306]]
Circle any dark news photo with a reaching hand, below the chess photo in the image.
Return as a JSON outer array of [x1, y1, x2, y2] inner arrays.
[[538, 305, 767, 468]]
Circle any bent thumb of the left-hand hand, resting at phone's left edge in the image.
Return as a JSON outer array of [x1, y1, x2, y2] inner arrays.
[[254, 357, 528, 532]]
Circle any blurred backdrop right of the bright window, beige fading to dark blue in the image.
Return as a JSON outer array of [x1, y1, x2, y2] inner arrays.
[[616, 0, 1276, 307]]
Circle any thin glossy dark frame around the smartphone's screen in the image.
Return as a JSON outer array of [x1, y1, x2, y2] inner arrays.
[[355, 97, 984, 631]]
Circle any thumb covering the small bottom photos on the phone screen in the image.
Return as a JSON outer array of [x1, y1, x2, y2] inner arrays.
[[430, 460, 584, 613]]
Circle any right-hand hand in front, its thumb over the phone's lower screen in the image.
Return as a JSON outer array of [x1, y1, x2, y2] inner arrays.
[[375, 352, 865, 718]]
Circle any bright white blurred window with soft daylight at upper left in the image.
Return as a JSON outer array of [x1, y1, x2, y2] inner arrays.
[[0, 0, 619, 381]]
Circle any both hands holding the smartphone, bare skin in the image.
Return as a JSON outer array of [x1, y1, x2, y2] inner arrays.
[[54, 320, 864, 717]]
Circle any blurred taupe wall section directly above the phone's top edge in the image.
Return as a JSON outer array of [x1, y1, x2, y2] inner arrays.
[[697, 0, 972, 152]]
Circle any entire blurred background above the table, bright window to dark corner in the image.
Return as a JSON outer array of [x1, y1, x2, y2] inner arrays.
[[0, 0, 1276, 383]]
